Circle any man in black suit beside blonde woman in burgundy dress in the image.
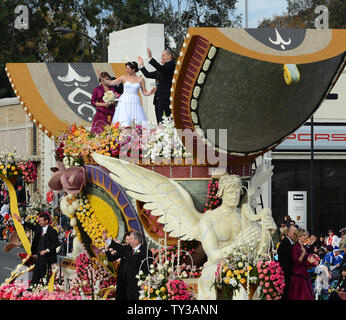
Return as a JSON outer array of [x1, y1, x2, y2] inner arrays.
[[278, 226, 297, 300]]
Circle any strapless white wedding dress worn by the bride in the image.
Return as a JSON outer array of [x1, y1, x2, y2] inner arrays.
[[112, 81, 146, 127]]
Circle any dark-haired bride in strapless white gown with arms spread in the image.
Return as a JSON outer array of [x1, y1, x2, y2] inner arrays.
[[98, 61, 155, 127]]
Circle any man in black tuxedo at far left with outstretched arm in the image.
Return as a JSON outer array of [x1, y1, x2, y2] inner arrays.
[[14, 213, 59, 285]]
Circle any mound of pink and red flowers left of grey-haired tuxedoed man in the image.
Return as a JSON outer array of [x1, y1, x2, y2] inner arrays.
[[71, 252, 116, 296]]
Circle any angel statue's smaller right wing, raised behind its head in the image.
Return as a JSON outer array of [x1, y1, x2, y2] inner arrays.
[[248, 159, 274, 208]]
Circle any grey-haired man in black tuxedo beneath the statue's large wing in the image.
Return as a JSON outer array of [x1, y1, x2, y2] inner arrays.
[[106, 231, 152, 300]]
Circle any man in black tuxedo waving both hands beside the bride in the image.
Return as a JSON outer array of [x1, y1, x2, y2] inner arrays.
[[138, 48, 175, 123]]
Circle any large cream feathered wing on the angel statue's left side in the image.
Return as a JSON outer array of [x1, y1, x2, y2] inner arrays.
[[92, 153, 202, 240]]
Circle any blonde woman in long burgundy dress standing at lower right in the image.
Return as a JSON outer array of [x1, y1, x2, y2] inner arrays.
[[287, 229, 314, 300]]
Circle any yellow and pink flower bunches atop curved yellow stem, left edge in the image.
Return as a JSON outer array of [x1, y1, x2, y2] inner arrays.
[[0, 151, 37, 184]]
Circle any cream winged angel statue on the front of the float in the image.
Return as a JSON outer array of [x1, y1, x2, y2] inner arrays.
[[93, 153, 276, 300]]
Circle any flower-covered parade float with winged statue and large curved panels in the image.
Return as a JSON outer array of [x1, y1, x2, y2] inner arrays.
[[0, 28, 346, 300]]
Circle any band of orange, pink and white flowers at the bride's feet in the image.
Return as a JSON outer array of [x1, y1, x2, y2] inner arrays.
[[56, 116, 190, 168]]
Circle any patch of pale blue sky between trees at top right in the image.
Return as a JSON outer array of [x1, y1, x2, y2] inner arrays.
[[237, 0, 287, 28]]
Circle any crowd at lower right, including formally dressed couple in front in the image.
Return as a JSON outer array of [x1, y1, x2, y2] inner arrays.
[[275, 216, 346, 300]]
